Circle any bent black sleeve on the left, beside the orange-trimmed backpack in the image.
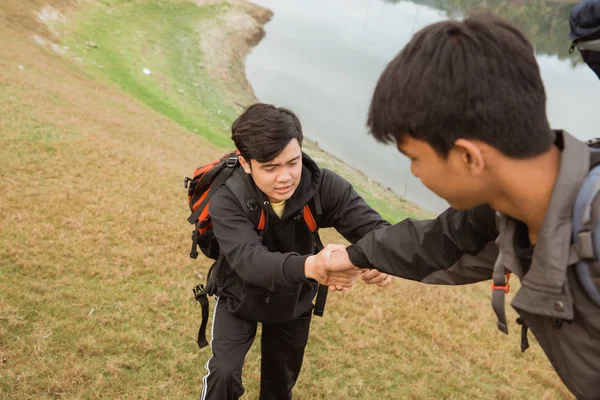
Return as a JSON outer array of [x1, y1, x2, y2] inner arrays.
[[209, 186, 308, 290]]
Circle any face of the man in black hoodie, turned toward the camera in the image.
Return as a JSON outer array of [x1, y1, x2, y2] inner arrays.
[[240, 139, 302, 203]]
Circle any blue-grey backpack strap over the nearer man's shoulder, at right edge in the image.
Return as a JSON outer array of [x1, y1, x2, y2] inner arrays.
[[572, 149, 600, 307]]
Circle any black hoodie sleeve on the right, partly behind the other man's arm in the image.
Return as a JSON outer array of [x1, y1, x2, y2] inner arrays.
[[320, 169, 390, 243]]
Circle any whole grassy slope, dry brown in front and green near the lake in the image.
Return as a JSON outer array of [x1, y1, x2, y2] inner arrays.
[[0, 0, 566, 399]]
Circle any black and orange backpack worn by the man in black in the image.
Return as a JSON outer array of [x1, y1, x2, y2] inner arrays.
[[184, 151, 328, 348]]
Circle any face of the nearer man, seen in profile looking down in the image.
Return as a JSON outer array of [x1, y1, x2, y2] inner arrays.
[[398, 135, 483, 209]]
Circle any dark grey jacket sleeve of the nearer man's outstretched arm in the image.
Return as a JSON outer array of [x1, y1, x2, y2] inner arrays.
[[348, 205, 498, 284]]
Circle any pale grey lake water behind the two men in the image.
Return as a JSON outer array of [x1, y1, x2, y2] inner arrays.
[[246, 0, 600, 211]]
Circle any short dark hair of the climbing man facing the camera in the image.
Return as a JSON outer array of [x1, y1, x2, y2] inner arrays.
[[231, 103, 304, 163]]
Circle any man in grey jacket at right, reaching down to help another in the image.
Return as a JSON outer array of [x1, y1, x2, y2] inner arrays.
[[328, 14, 600, 399]]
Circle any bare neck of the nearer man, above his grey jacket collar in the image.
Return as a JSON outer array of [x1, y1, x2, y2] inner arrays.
[[488, 146, 560, 244]]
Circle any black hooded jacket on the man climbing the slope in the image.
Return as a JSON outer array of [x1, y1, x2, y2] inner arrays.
[[209, 154, 389, 323]]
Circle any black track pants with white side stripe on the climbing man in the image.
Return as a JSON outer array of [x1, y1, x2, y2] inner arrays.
[[200, 297, 311, 400]]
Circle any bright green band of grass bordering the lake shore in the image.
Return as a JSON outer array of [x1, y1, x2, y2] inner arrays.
[[57, 1, 432, 225]]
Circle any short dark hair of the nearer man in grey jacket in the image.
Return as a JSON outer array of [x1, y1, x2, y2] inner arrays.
[[367, 13, 554, 158]]
